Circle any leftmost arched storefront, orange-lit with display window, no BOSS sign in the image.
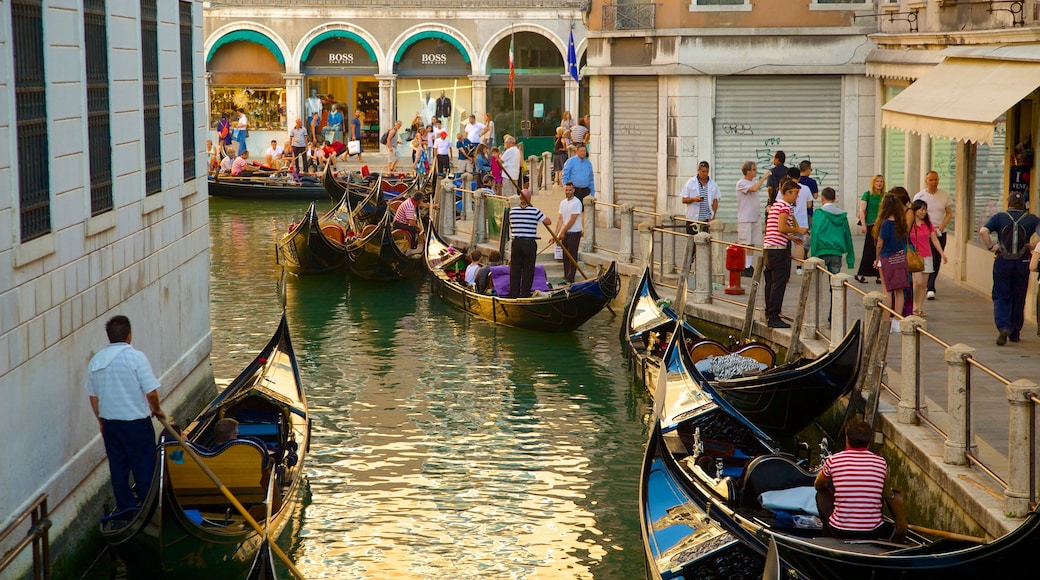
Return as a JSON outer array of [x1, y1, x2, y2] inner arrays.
[[206, 30, 287, 149]]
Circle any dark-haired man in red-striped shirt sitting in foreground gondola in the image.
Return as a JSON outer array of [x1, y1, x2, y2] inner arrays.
[[815, 419, 888, 539]]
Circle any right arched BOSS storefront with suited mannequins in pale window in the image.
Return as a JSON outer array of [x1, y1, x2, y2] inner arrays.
[[394, 31, 472, 140]]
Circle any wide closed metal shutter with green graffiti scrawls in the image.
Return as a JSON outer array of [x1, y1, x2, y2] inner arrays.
[[715, 75, 841, 225]]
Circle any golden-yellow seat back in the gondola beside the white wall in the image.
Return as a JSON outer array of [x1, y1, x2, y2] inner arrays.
[[165, 440, 268, 507]]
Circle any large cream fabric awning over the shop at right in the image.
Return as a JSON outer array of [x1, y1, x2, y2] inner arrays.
[[881, 57, 1040, 143]]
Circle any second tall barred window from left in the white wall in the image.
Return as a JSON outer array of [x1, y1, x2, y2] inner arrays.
[[83, 0, 113, 216]]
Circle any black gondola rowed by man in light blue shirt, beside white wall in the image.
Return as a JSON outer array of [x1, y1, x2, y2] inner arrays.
[[101, 312, 310, 578]]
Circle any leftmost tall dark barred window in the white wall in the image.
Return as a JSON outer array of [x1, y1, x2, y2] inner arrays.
[[10, 0, 51, 242]]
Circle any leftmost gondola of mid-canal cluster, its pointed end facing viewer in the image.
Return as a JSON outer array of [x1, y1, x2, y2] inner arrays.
[[275, 202, 346, 275]]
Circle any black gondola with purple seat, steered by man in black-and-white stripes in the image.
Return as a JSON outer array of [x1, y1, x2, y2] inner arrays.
[[425, 226, 621, 333]]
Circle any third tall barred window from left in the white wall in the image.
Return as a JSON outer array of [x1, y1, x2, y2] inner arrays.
[[140, 0, 162, 195]]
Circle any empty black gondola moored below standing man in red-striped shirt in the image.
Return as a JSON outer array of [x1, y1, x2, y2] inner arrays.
[[624, 268, 862, 439]]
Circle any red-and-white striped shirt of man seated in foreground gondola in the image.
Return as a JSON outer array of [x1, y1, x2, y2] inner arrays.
[[824, 449, 888, 531]]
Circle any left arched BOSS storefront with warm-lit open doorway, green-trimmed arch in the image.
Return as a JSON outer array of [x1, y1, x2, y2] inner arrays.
[[301, 30, 380, 150]]
